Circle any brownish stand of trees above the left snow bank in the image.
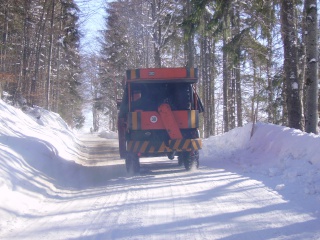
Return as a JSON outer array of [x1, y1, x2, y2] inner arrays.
[[0, 0, 84, 127]]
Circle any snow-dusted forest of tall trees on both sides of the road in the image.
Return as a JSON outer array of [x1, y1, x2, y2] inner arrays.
[[0, 0, 320, 137]]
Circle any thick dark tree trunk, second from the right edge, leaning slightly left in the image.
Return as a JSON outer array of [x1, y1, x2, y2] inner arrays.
[[281, 0, 302, 129]]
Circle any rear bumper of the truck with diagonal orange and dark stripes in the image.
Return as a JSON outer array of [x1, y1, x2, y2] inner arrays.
[[127, 138, 202, 153]]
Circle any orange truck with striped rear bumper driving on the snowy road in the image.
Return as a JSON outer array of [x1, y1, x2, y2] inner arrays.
[[118, 67, 204, 174]]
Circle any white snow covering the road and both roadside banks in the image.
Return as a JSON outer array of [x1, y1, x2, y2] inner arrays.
[[0, 100, 320, 240]]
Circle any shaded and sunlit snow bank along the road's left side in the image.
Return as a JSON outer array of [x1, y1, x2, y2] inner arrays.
[[0, 100, 77, 217]]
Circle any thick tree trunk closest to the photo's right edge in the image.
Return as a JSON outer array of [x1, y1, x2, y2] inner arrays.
[[305, 0, 318, 133]]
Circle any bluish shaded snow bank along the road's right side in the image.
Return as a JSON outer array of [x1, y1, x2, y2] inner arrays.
[[202, 123, 320, 194]]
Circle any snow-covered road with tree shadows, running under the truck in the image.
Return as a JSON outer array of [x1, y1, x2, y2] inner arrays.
[[0, 135, 320, 240]]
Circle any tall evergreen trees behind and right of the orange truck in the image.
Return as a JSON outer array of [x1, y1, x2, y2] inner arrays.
[[91, 0, 319, 137]]
